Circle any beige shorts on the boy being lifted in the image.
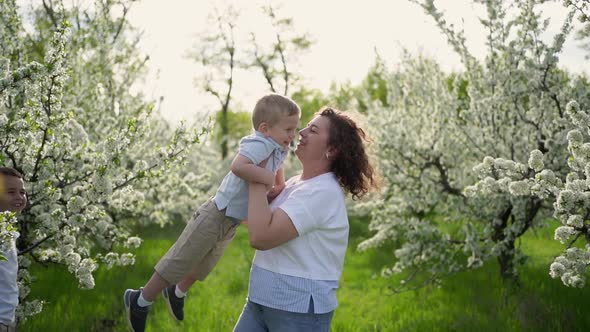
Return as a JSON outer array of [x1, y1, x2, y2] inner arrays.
[[154, 199, 239, 284]]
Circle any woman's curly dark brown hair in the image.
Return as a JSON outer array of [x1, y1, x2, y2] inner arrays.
[[317, 107, 378, 199]]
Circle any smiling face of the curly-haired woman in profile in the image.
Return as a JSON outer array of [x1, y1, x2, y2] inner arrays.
[[295, 115, 330, 162]]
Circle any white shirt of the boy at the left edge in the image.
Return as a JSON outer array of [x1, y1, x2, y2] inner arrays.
[[0, 240, 18, 325]]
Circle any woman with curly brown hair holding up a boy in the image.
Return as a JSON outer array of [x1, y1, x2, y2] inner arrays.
[[234, 108, 376, 332]]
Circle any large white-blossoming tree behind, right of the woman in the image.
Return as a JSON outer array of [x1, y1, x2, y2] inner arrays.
[[360, 0, 590, 288]]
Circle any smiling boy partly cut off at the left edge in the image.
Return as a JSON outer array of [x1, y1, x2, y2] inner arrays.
[[0, 167, 27, 332]]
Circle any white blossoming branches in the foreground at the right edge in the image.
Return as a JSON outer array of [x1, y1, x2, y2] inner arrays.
[[465, 101, 590, 287]]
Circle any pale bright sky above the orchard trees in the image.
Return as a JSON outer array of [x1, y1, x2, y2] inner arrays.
[[129, 0, 590, 123]]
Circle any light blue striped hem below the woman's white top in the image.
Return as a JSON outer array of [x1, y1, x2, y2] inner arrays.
[[248, 264, 338, 314]]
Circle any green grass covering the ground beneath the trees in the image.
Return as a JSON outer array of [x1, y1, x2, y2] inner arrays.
[[20, 220, 590, 332]]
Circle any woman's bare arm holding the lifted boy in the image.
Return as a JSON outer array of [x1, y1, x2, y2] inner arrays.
[[248, 183, 299, 250]]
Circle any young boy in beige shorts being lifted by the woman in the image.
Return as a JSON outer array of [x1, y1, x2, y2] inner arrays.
[[124, 94, 301, 332]]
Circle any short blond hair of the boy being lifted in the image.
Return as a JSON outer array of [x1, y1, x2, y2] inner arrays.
[[252, 93, 301, 130]]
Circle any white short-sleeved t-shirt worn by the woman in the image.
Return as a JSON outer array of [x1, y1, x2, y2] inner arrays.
[[253, 172, 349, 280]]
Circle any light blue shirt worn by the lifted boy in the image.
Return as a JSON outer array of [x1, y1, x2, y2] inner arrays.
[[213, 131, 288, 221]]
